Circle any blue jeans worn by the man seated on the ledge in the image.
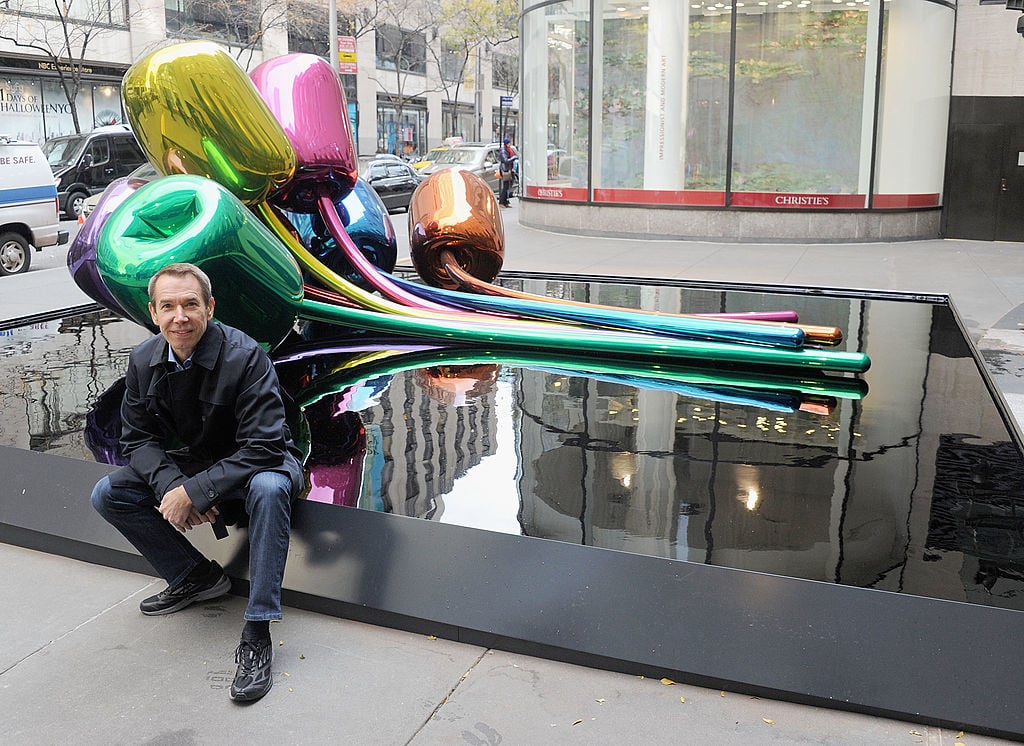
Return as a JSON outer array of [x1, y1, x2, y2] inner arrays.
[[92, 472, 291, 621]]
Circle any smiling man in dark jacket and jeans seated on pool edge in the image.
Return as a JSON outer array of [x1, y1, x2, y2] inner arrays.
[[92, 264, 303, 701]]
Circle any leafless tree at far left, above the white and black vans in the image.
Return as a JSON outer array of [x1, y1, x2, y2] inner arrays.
[[0, 0, 128, 132]]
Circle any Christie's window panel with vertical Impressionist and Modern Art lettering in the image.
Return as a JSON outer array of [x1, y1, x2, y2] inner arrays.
[[593, 0, 732, 205]]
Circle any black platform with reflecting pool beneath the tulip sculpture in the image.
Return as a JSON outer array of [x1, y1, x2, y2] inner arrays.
[[0, 275, 1024, 736]]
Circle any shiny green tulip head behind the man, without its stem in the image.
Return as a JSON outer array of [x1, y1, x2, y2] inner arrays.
[[96, 176, 302, 347]]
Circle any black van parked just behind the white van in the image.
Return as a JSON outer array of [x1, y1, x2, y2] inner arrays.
[[43, 125, 146, 218]]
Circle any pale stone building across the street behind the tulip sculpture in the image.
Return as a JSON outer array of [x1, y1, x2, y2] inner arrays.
[[0, 0, 518, 158]]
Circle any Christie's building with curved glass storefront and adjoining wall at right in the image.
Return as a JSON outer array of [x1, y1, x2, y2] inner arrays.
[[520, 0, 1024, 240]]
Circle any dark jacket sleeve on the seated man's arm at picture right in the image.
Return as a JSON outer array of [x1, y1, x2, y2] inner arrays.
[[184, 349, 289, 513]]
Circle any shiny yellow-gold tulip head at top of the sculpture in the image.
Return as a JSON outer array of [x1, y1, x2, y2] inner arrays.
[[122, 41, 296, 205]]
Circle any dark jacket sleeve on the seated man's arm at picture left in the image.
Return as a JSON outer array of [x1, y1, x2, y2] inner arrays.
[[121, 353, 185, 499]]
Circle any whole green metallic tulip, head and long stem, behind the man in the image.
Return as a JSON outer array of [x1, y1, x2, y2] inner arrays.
[[96, 176, 869, 372]]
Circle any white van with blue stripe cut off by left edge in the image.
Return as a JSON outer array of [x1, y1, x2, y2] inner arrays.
[[0, 135, 68, 276]]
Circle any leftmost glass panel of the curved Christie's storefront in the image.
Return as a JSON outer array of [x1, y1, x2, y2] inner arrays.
[[520, 0, 591, 201]]
